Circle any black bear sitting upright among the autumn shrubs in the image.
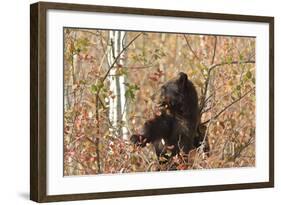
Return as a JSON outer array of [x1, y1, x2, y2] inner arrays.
[[131, 72, 200, 160]]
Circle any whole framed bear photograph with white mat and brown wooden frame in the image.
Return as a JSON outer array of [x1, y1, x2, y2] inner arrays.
[[30, 2, 274, 202]]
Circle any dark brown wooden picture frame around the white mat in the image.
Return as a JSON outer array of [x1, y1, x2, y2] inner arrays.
[[30, 2, 274, 202]]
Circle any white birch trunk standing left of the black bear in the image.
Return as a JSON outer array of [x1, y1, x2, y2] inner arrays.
[[108, 31, 128, 139]]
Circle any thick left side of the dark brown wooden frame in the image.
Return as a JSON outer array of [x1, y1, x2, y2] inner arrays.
[[30, 3, 46, 202]]
